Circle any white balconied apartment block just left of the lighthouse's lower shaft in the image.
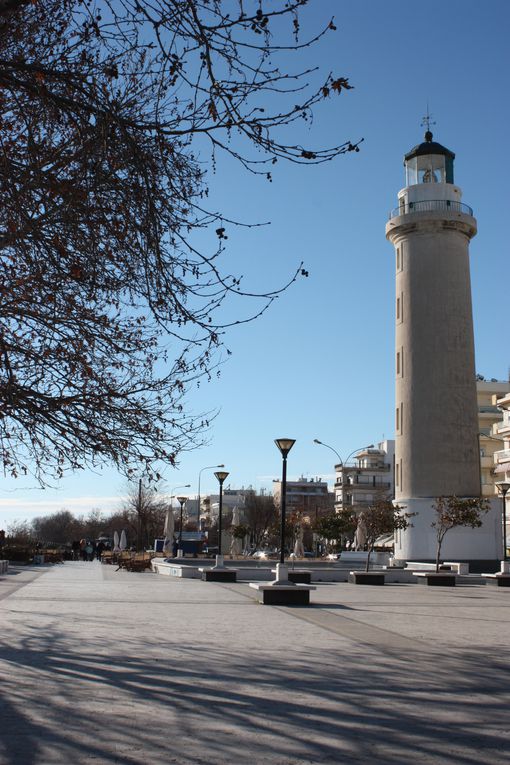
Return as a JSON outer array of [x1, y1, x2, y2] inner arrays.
[[335, 439, 395, 512]]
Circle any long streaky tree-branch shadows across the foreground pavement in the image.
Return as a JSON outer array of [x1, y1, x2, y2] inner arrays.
[[0, 623, 509, 765]]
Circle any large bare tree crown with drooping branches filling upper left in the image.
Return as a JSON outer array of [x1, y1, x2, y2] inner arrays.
[[0, 0, 358, 482]]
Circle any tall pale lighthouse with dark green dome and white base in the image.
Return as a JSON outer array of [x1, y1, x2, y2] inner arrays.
[[386, 130, 499, 561]]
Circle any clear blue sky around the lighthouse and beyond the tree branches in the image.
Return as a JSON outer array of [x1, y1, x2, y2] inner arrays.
[[0, 0, 510, 527]]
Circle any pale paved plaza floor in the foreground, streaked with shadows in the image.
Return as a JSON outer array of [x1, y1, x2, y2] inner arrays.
[[0, 562, 510, 765]]
